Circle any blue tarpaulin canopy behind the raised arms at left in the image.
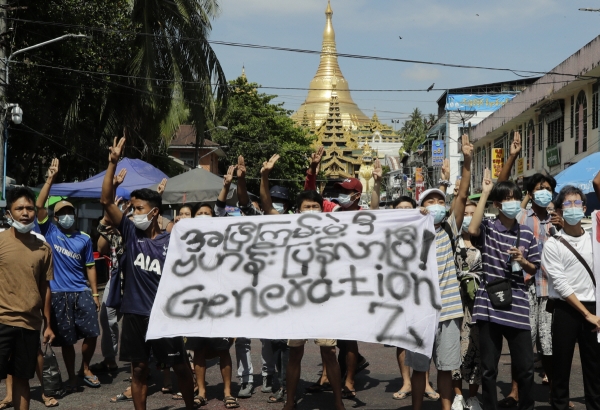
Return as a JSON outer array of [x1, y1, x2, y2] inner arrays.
[[50, 158, 168, 199]]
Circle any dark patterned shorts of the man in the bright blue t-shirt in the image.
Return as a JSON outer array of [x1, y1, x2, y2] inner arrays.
[[50, 290, 100, 346]]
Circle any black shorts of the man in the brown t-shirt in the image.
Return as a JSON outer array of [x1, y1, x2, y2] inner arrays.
[[0, 324, 40, 380]]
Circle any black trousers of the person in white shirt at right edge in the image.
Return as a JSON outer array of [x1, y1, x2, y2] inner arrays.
[[551, 300, 600, 410]]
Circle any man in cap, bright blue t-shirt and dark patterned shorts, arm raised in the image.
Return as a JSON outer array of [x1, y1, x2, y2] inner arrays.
[[36, 158, 100, 391]]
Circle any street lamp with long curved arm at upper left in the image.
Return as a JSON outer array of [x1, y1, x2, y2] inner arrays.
[[0, 34, 91, 200]]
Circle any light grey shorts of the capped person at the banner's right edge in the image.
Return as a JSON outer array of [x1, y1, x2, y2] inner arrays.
[[405, 319, 462, 372]]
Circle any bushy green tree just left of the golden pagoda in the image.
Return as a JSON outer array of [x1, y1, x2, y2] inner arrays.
[[213, 77, 313, 199]]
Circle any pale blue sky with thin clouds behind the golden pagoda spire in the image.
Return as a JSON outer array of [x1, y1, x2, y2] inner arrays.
[[211, 0, 600, 125]]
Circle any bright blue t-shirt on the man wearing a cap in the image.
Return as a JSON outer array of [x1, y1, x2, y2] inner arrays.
[[38, 217, 95, 292]]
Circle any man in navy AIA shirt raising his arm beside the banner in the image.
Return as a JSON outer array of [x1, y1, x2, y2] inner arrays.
[[100, 138, 194, 410]]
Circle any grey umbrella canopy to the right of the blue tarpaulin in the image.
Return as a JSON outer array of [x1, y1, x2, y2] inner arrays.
[[150, 168, 237, 205]]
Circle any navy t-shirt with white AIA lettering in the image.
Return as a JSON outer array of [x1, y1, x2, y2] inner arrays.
[[119, 217, 171, 316]]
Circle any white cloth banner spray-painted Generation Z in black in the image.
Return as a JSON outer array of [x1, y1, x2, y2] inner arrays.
[[147, 210, 441, 356]]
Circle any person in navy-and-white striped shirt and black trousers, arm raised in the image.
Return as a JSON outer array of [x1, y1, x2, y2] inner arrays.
[[469, 169, 540, 410]]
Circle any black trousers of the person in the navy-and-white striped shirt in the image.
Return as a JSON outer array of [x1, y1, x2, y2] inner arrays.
[[477, 321, 535, 410]]
